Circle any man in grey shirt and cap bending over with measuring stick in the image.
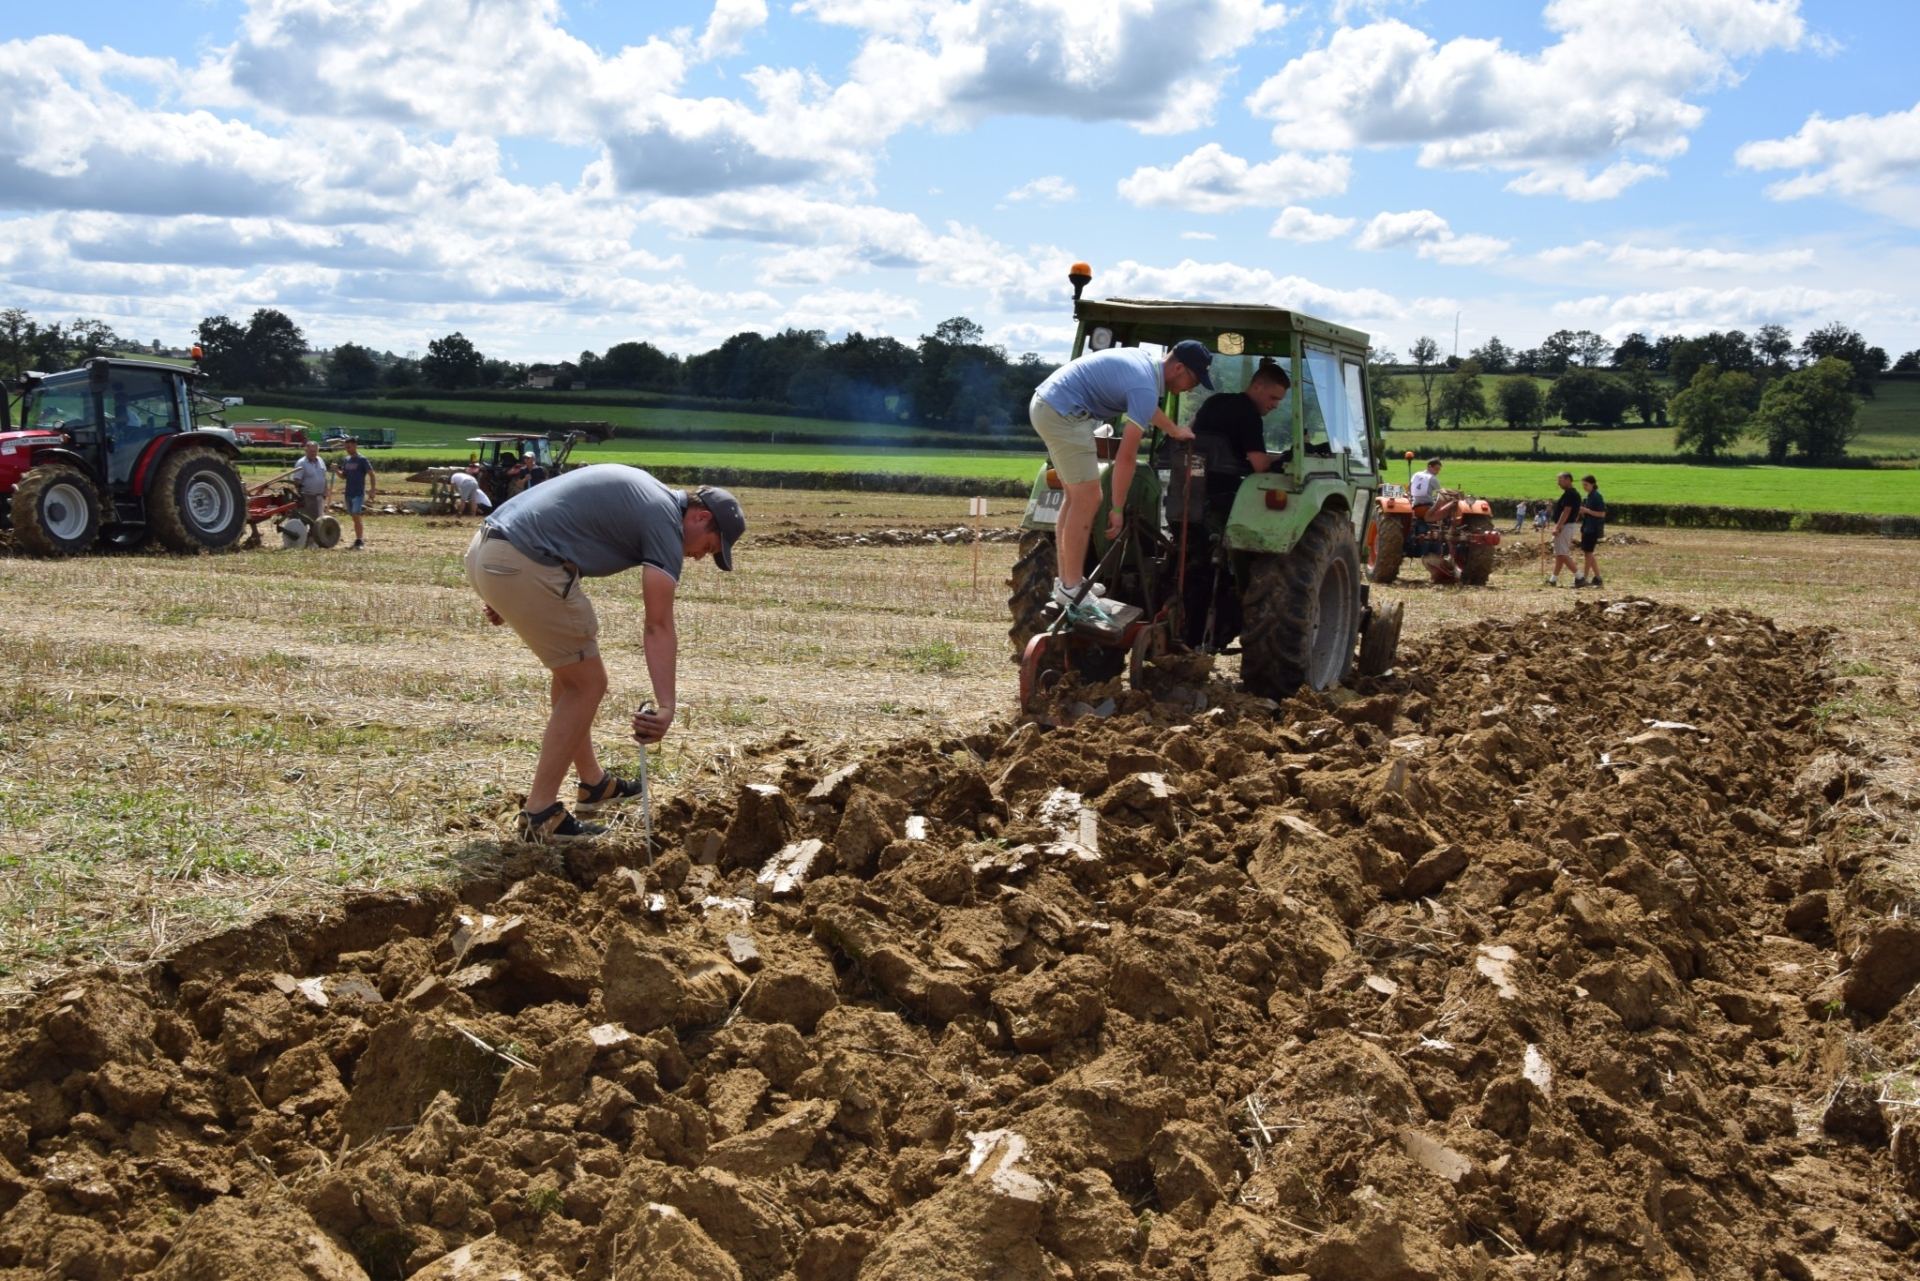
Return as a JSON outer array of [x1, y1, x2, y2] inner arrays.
[[467, 465, 747, 841]]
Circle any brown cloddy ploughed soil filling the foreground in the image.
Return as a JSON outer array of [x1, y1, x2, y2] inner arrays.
[[0, 601, 1920, 1281]]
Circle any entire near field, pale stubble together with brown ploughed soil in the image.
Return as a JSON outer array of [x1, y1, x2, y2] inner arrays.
[[0, 492, 1920, 1281]]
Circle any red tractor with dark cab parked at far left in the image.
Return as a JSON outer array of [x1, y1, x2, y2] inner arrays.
[[0, 357, 246, 557]]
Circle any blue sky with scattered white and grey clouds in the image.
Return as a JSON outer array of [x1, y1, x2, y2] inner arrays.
[[0, 0, 1920, 359]]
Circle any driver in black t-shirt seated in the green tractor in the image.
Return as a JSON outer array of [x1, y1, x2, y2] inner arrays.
[[1169, 361, 1292, 645]]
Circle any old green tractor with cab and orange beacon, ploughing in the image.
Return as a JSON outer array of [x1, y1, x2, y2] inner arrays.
[[1008, 265, 1402, 707]]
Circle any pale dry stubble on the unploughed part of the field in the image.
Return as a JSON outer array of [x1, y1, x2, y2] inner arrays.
[[0, 492, 1920, 987]]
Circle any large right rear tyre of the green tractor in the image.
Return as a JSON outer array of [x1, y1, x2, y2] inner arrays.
[[1240, 509, 1359, 699]]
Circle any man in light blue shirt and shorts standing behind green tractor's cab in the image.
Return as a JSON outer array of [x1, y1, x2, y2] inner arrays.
[[1027, 338, 1213, 624]]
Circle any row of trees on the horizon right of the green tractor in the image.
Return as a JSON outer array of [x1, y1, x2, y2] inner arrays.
[[1380, 321, 1920, 465]]
